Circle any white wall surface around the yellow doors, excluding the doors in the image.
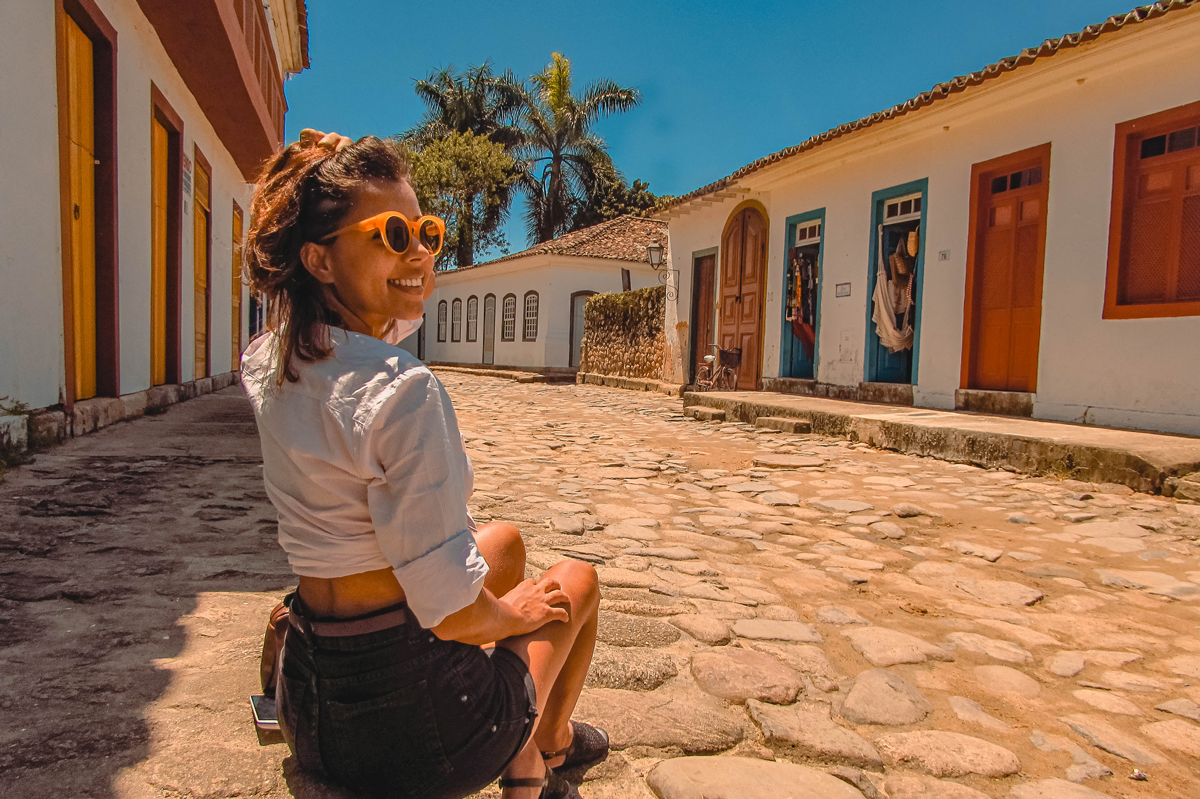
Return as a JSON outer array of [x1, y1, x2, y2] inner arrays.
[[0, 0, 251, 408]]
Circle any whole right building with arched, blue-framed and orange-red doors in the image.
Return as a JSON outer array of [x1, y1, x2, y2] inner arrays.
[[665, 0, 1200, 434]]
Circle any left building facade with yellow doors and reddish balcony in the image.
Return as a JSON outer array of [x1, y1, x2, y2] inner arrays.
[[0, 0, 307, 437]]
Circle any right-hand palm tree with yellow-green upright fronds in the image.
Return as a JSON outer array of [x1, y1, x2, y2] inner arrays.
[[518, 53, 641, 242]]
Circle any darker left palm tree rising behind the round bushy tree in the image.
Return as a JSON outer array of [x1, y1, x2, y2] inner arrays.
[[400, 61, 526, 266]]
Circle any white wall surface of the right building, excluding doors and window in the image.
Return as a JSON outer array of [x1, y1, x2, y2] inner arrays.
[[668, 10, 1200, 434]]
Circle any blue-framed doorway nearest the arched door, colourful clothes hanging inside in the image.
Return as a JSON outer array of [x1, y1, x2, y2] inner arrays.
[[779, 209, 824, 380]]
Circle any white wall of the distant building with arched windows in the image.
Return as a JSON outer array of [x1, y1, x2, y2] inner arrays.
[[424, 256, 658, 368]]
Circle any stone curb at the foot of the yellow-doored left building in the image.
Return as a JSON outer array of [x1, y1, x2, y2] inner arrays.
[[22, 372, 239, 446]]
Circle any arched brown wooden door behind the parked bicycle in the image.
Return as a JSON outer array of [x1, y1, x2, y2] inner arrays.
[[719, 208, 767, 391]]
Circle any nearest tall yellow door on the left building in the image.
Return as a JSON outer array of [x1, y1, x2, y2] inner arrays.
[[66, 17, 96, 400]]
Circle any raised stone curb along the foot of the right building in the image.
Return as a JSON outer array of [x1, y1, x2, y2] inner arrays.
[[683, 391, 1200, 494]]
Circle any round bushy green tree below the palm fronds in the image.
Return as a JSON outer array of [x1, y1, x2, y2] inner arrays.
[[409, 132, 517, 269]]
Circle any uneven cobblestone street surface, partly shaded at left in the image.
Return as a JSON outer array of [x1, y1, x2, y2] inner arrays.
[[0, 373, 1200, 799]]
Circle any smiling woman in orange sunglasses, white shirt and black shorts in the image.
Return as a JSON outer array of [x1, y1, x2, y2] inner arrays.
[[242, 131, 608, 799]]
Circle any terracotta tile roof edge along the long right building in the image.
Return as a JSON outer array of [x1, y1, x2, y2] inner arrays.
[[660, 0, 1200, 212]]
